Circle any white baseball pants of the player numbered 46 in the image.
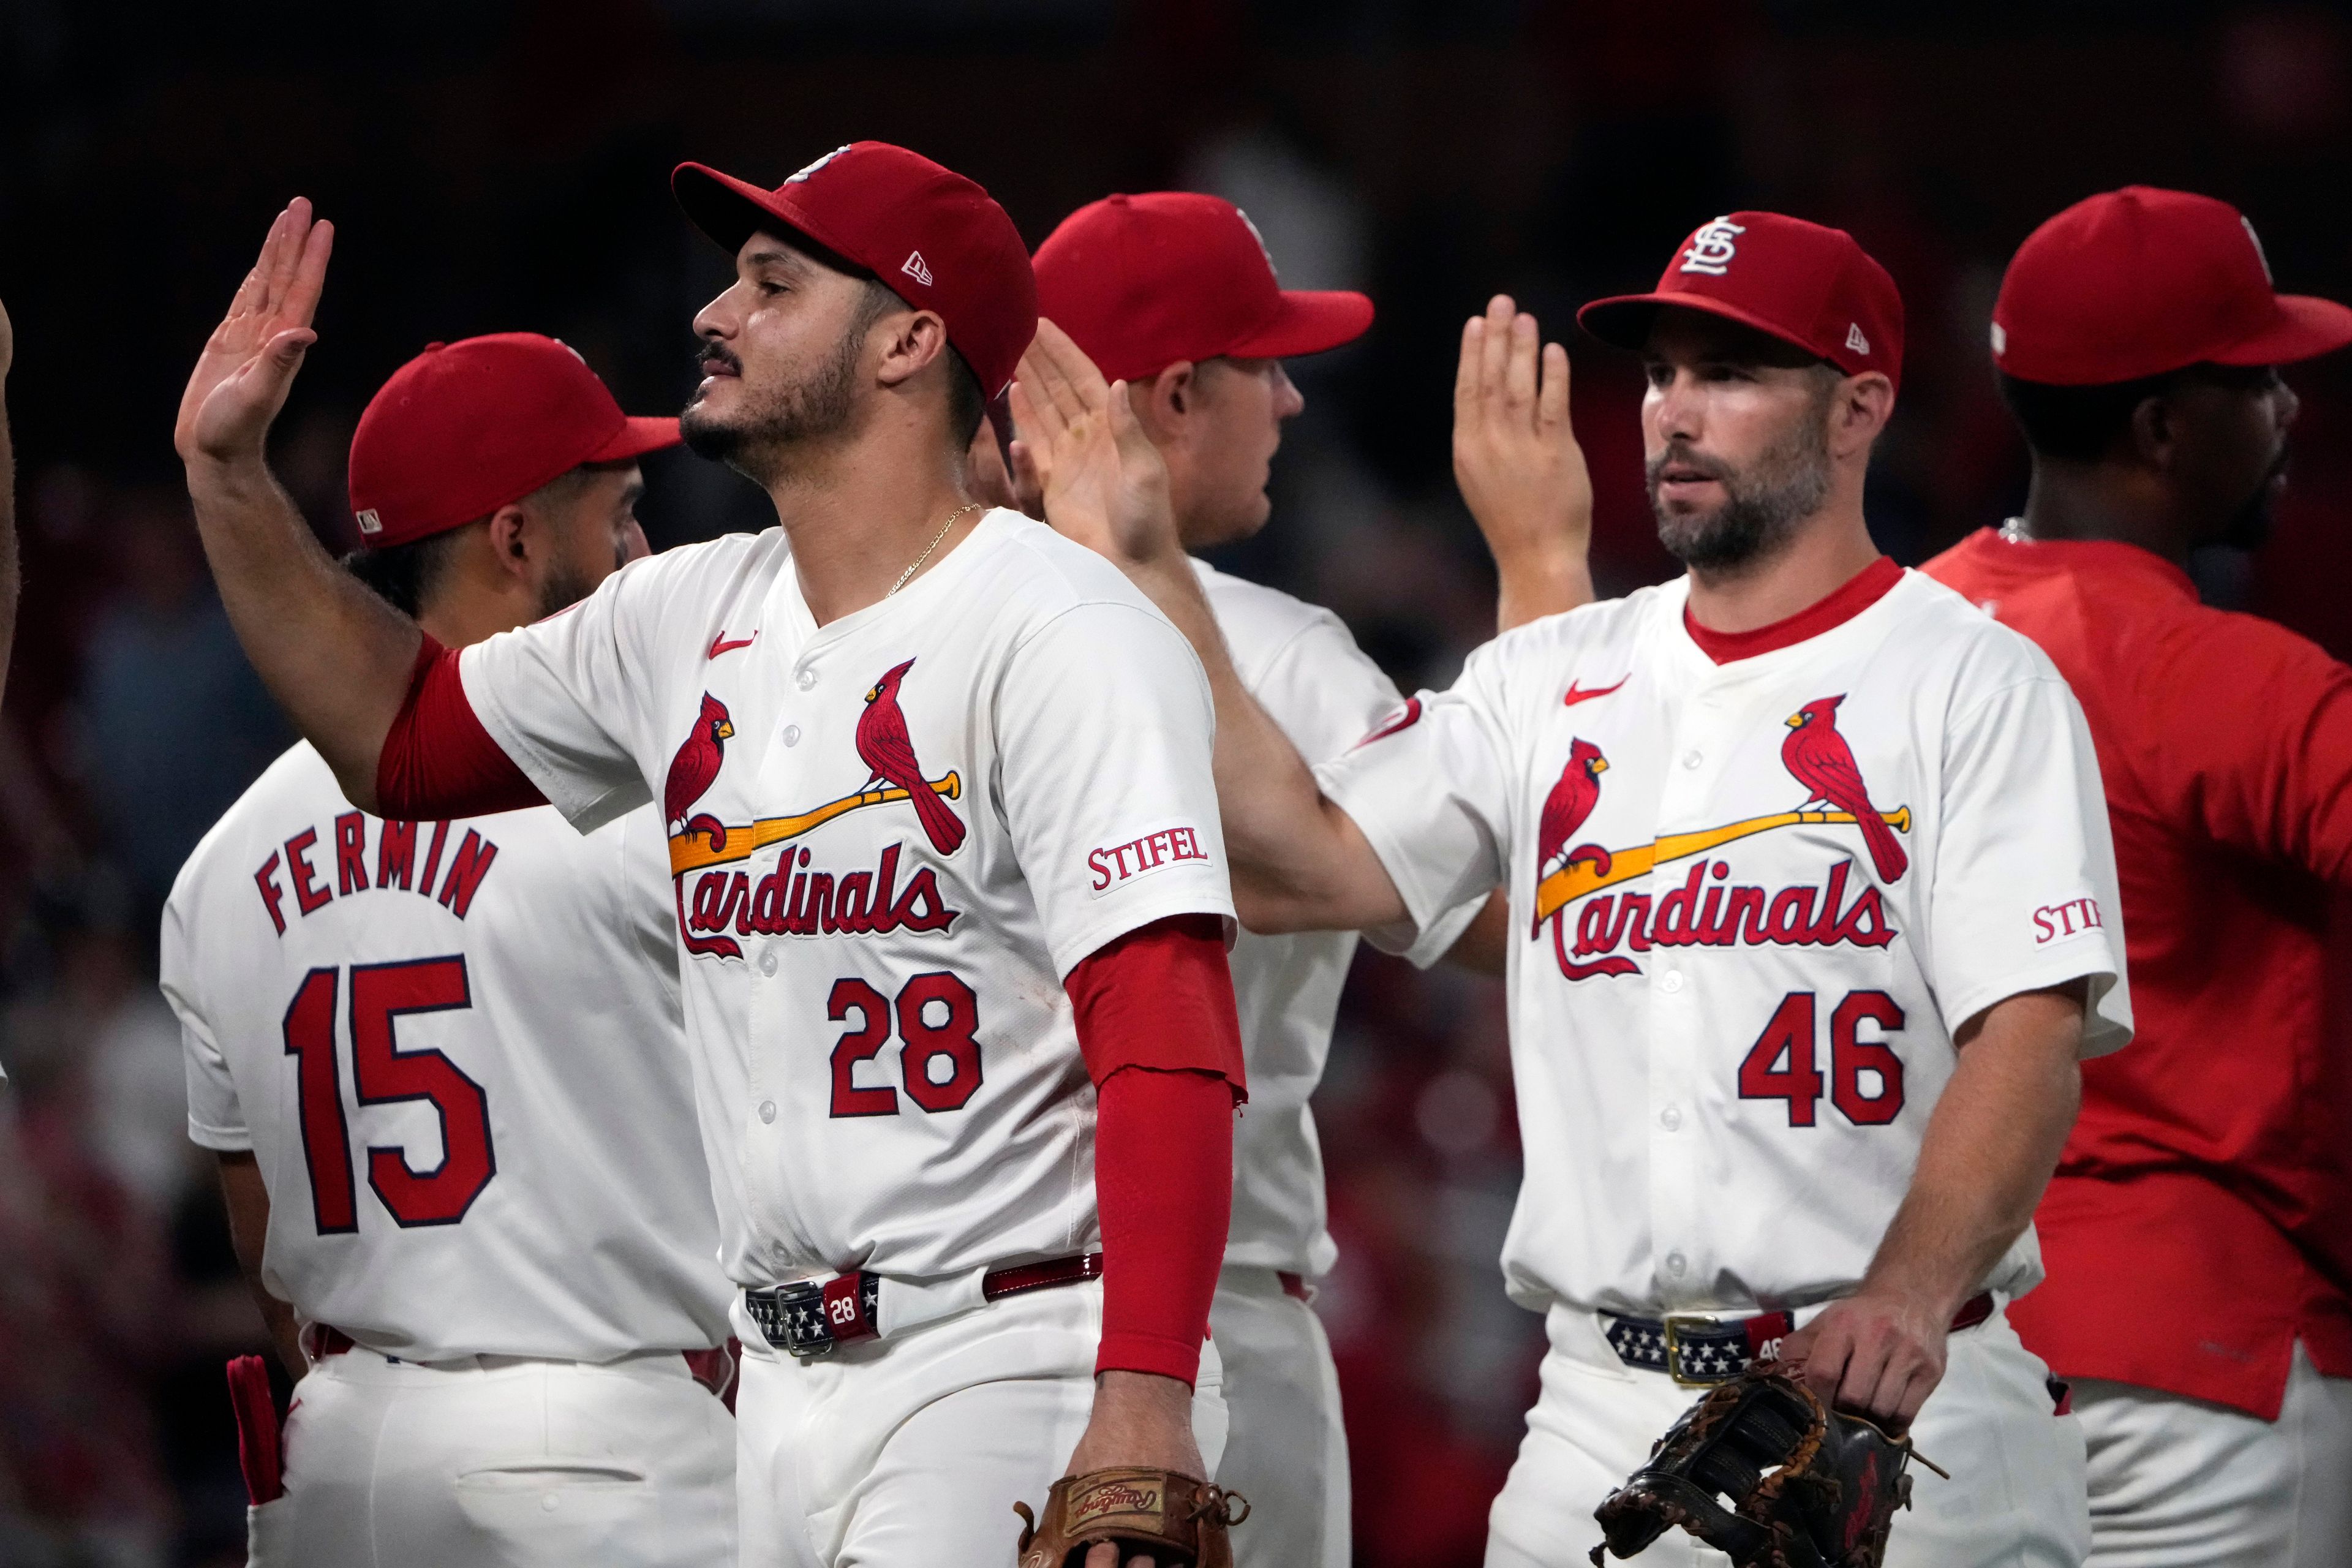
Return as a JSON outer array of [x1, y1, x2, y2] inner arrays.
[[1487, 1305, 2091, 1568]]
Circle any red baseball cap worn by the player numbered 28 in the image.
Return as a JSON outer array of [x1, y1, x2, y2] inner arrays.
[[670, 141, 1037, 399]]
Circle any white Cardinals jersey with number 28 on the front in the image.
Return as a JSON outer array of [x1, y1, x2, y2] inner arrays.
[[459, 510, 1232, 1286]]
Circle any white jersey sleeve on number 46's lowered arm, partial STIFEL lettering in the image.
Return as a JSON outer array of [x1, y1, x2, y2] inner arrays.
[[1929, 649, 2131, 1058]]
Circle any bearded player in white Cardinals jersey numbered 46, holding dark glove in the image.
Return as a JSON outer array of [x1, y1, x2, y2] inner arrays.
[[1023, 211, 2128, 1566]]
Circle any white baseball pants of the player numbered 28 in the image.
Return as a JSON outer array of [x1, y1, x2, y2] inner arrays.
[[736, 1281, 1246, 1568]]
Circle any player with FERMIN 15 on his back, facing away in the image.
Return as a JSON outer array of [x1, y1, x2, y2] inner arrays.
[[162, 334, 734, 1568]]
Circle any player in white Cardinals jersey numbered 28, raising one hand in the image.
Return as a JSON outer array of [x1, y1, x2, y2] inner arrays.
[[181, 141, 1244, 1568]]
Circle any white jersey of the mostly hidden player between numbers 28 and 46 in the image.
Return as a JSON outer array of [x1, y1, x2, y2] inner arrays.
[[1193, 562, 1484, 1276]]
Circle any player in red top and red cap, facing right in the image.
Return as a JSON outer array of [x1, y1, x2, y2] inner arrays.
[[1926, 188, 2352, 1568]]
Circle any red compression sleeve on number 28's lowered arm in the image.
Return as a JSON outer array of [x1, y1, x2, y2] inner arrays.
[[1068, 914, 1244, 1382]]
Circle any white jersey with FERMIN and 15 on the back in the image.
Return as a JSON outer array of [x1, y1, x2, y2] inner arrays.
[[162, 743, 729, 1361]]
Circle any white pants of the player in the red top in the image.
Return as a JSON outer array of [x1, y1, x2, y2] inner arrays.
[[2075, 1344, 2352, 1568]]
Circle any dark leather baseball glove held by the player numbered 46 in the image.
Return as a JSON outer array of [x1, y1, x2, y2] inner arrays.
[[1593, 1363, 1940, 1568]]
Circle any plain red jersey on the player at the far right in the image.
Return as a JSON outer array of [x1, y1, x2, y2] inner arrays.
[[1926, 529, 2352, 1420]]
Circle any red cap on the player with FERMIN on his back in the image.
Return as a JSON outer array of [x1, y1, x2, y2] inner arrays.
[[350, 331, 677, 550]]
